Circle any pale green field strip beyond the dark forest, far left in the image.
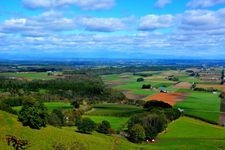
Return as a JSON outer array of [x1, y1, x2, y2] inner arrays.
[[0, 72, 60, 80]]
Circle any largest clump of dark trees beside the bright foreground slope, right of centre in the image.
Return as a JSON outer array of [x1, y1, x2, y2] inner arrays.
[[128, 101, 181, 143]]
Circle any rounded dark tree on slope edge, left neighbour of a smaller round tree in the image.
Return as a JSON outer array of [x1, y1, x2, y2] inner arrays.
[[77, 118, 96, 133]]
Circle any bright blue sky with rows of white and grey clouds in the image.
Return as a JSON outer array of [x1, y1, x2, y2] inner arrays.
[[0, 0, 225, 59]]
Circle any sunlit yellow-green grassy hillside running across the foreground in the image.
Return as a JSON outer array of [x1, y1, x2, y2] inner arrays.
[[0, 111, 225, 150]]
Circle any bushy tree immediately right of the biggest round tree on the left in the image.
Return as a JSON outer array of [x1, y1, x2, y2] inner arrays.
[[48, 109, 65, 127]]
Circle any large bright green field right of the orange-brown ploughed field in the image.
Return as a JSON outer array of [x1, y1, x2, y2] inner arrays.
[[175, 90, 220, 123]]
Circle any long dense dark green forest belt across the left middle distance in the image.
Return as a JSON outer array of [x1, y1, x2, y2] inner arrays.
[[0, 75, 126, 103]]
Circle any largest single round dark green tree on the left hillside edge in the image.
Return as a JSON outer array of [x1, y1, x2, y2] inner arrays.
[[18, 97, 48, 129]]
